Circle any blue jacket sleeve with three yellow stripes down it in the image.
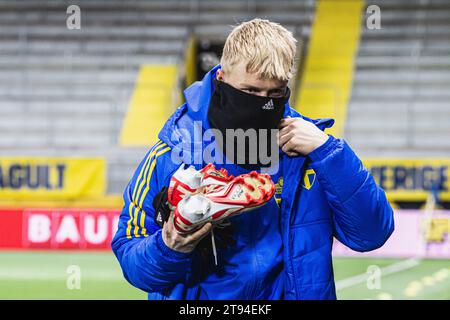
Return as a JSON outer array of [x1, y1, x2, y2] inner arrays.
[[112, 141, 191, 292]]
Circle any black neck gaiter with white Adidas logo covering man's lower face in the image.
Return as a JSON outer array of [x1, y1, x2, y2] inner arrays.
[[208, 79, 290, 170]]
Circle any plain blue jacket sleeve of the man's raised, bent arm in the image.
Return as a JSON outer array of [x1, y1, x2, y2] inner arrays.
[[308, 135, 394, 252]]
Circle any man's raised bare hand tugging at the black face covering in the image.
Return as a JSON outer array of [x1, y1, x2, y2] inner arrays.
[[278, 118, 328, 157]]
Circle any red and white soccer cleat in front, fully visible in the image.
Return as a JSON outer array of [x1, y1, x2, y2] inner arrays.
[[174, 171, 275, 233]]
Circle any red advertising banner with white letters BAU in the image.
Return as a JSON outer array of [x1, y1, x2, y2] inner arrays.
[[0, 209, 120, 249]]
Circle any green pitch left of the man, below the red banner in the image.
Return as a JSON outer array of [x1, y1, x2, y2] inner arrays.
[[0, 251, 146, 299]]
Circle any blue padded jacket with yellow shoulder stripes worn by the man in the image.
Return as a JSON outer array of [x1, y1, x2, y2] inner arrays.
[[112, 65, 394, 299]]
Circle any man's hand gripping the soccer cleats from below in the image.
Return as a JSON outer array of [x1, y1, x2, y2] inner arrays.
[[162, 213, 212, 253]]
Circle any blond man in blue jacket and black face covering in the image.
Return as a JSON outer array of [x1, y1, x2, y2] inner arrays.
[[112, 19, 394, 299]]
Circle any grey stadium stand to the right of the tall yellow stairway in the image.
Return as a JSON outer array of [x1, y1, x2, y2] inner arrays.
[[345, 0, 450, 158]]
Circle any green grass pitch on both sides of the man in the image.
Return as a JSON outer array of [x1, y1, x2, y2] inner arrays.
[[0, 251, 450, 299]]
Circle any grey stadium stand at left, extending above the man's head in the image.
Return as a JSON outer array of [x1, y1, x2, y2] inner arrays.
[[0, 0, 315, 194]]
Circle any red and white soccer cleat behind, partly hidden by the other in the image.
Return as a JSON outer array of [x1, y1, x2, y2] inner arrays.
[[167, 163, 234, 209]]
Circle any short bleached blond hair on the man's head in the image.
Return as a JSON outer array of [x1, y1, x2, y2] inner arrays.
[[220, 19, 297, 81]]
